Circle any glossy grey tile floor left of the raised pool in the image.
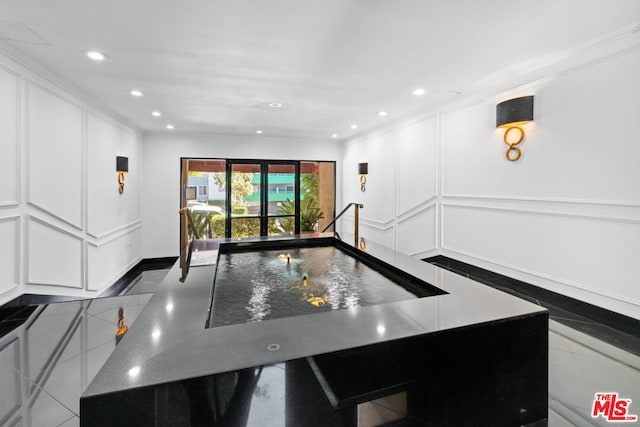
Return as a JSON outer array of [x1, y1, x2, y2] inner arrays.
[[0, 295, 151, 426]]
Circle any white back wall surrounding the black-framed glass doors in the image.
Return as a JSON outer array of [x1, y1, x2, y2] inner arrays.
[[142, 133, 341, 258]]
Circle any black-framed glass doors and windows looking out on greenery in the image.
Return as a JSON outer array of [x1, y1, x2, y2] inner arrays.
[[181, 159, 335, 247]]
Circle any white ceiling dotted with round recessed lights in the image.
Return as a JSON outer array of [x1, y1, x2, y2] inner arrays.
[[0, 0, 640, 139]]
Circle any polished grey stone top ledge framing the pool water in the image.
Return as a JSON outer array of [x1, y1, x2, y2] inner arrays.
[[83, 234, 546, 397]]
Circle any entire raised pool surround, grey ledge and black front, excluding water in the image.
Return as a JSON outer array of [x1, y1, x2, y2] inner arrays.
[[80, 238, 548, 427]]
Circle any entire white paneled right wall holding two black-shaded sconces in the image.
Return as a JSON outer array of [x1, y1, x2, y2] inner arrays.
[[343, 33, 640, 319]]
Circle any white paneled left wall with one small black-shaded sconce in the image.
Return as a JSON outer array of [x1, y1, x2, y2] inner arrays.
[[0, 53, 142, 304]]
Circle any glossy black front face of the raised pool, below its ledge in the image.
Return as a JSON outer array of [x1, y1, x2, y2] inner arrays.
[[77, 308, 547, 427]]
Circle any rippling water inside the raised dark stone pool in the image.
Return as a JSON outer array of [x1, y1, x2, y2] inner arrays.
[[209, 246, 424, 327]]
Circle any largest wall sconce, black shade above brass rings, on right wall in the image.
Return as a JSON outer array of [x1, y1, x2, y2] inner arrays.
[[496, 96, 533, 162]]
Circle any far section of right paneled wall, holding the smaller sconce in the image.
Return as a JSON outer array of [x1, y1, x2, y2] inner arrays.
[[339, 116, 438, 256]]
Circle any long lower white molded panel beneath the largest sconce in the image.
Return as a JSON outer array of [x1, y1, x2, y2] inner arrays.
[[441, 203, 640, 310]]
